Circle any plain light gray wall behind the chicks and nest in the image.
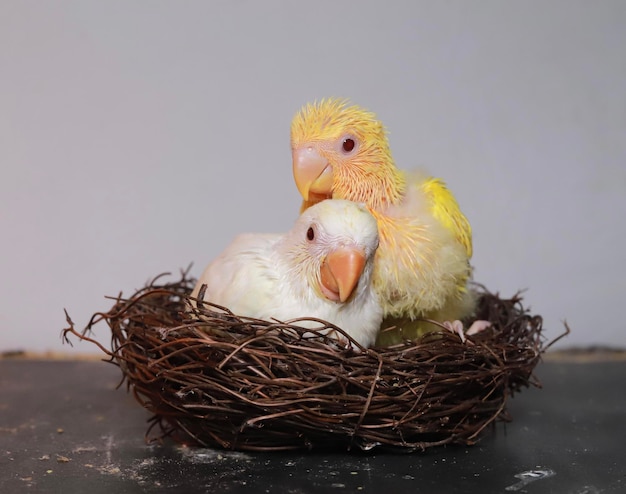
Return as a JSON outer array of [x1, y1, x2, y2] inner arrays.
[[0, 0, 626, 351]]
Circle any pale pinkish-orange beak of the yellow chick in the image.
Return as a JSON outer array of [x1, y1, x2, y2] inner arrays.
[[291, 145, 333, 201]]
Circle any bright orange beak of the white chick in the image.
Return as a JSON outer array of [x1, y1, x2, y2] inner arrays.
[[320, 247, 365, 303]]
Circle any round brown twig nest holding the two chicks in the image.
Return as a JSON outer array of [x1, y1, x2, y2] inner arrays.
[[64, 272, 560, 451]]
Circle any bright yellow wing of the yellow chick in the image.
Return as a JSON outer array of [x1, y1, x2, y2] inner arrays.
[[421, 177, 472, 259]]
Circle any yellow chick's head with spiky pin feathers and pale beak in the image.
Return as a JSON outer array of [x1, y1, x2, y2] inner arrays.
[[291, 99, 405, 209]]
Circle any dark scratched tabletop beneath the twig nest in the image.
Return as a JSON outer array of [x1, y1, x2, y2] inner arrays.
[[0, 359, 626, 494]]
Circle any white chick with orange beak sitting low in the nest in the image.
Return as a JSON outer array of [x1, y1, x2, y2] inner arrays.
[[191, 199, 382, 347]]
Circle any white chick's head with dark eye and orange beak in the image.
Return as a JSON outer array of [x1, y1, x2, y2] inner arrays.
[[284, 199, 378, 303]]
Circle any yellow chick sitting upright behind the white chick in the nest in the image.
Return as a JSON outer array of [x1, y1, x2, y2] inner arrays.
[[291, 99, 476, 345]]
